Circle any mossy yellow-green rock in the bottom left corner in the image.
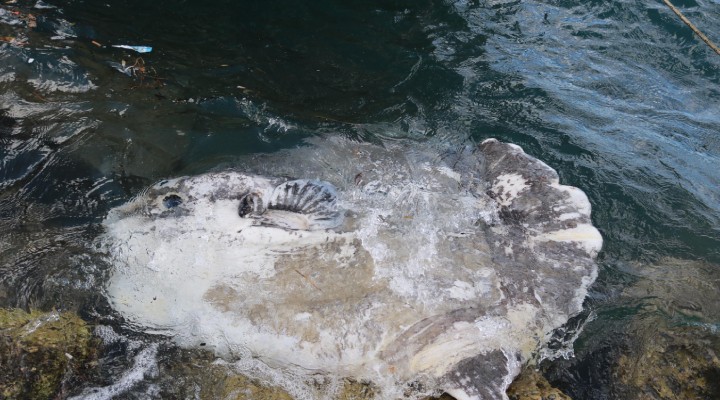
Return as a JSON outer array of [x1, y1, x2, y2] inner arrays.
[[0, 309, 95, 399]]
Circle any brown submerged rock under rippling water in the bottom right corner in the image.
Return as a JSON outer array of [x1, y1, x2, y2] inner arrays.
[[613, 258, 720, 400]]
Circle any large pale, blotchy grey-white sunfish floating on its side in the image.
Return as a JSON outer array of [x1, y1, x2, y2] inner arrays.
[[100, 138, 602, 399]]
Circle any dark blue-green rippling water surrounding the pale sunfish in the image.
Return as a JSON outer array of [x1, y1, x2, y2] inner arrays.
[[0, 0, 720, 398]]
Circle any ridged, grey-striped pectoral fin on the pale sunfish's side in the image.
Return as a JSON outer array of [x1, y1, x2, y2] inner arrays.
[[260, 179, 343, 230]]
